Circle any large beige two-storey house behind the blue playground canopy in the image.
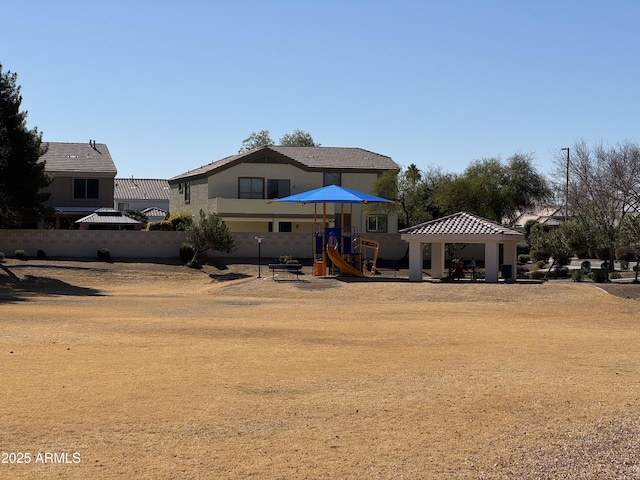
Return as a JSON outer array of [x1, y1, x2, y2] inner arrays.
[[169, 146, 400, 233]]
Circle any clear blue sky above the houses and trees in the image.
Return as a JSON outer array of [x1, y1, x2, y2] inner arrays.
[[0, 0, 640, 178]]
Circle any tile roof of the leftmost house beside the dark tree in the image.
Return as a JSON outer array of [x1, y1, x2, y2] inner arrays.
[[39, 142, 117, 176]]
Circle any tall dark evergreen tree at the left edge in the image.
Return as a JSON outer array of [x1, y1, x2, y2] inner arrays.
[[0, 64, 52, 227]]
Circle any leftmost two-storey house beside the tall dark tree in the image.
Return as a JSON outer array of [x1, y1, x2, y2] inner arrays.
[[39, 140, 117, 229]]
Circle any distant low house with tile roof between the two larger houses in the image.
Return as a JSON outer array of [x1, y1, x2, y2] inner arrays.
[[113, 178, 169, 222]]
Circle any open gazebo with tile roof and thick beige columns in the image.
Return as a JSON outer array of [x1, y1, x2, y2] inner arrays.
[[400, 212, 524, 283]]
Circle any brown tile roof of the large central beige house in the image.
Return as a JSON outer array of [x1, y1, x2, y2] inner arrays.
[[169, 146, 400, 181]]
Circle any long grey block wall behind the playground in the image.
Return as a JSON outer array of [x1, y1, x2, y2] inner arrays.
[[0, 229, 407, 262]]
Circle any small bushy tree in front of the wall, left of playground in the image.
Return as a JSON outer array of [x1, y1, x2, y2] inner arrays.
[[185, 210, 236, 266]]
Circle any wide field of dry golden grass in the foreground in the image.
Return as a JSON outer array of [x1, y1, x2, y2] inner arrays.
[[0, 260, 640, 479]]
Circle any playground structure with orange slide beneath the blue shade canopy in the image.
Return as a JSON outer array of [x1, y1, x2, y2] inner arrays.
[[313, 227, 380, 277]]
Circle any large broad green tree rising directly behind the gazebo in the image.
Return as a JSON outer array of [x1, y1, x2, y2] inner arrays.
[[433, 153, 552, 223]]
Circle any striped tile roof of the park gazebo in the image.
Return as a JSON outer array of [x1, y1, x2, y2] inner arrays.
[[400, 212, 524, 237]]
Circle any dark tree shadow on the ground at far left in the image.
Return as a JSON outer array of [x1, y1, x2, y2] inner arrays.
[[0, 265, 102, 303]]
